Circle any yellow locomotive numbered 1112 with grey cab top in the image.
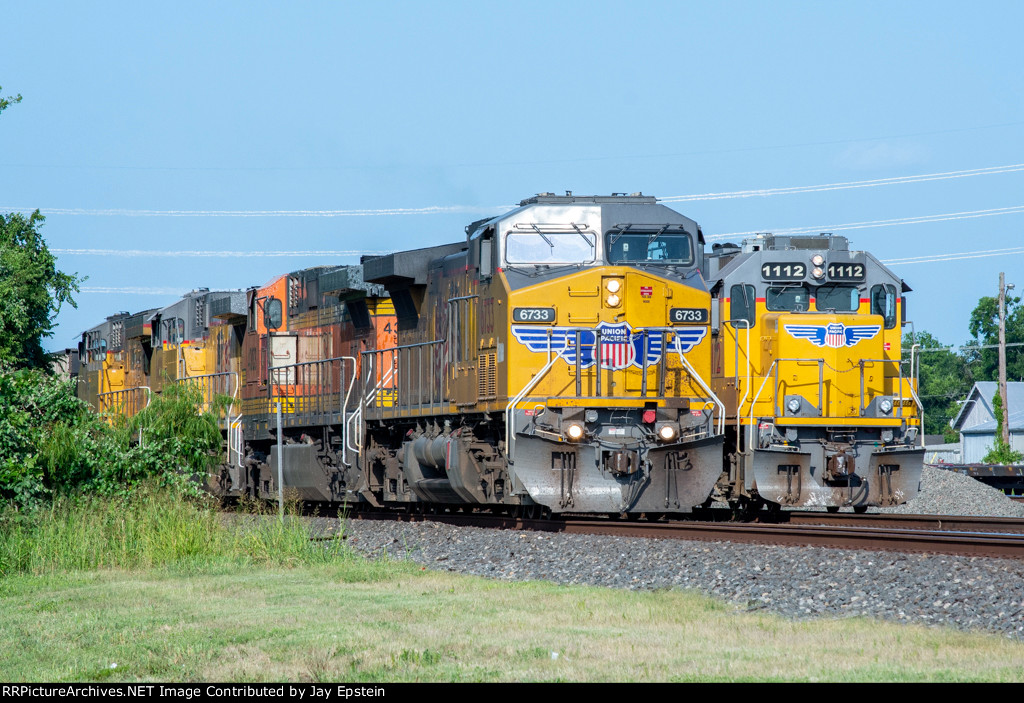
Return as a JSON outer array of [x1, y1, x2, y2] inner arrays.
[[708, 234, 924, 512]]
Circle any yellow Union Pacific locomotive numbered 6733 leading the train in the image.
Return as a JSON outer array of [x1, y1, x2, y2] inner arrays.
[[360, 193, 724, 516]]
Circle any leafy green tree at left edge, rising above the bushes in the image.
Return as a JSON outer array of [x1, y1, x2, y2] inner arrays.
[[0, 210, 79, 368]]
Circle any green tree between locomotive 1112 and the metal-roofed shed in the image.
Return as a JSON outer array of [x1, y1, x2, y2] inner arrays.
[[903, 332, 974, 442]]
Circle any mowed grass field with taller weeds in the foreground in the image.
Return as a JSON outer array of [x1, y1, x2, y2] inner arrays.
[[0, 495, 1024, 683]]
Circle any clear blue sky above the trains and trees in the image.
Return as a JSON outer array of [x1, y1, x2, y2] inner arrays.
[[0, 1, 1024, 349]]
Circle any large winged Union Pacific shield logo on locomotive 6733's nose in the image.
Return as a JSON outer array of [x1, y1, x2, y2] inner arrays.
[[512, 322, 708, 370]]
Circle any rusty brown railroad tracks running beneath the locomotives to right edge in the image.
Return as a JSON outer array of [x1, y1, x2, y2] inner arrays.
[[342, 511, 1024, 559]]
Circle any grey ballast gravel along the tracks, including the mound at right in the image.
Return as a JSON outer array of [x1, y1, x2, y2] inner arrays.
[[345, 468, 1024, 640]]
